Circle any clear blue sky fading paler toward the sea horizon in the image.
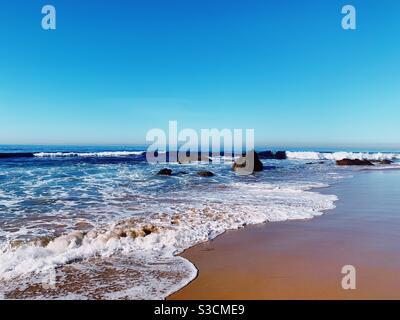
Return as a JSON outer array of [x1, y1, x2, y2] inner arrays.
[[0, 0, 400, 147]]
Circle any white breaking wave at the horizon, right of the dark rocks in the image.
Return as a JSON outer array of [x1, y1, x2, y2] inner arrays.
[[286, 151, 400, 160]]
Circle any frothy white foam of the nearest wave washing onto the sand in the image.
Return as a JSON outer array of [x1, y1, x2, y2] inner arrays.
[[0, 183, 337, 299]]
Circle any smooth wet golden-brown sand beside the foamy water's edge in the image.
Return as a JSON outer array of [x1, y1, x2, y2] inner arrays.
[[169, 170, 400, 299]]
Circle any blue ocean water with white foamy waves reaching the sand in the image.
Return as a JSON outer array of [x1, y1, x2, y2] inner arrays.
[[0, 146, 400, 299]]
